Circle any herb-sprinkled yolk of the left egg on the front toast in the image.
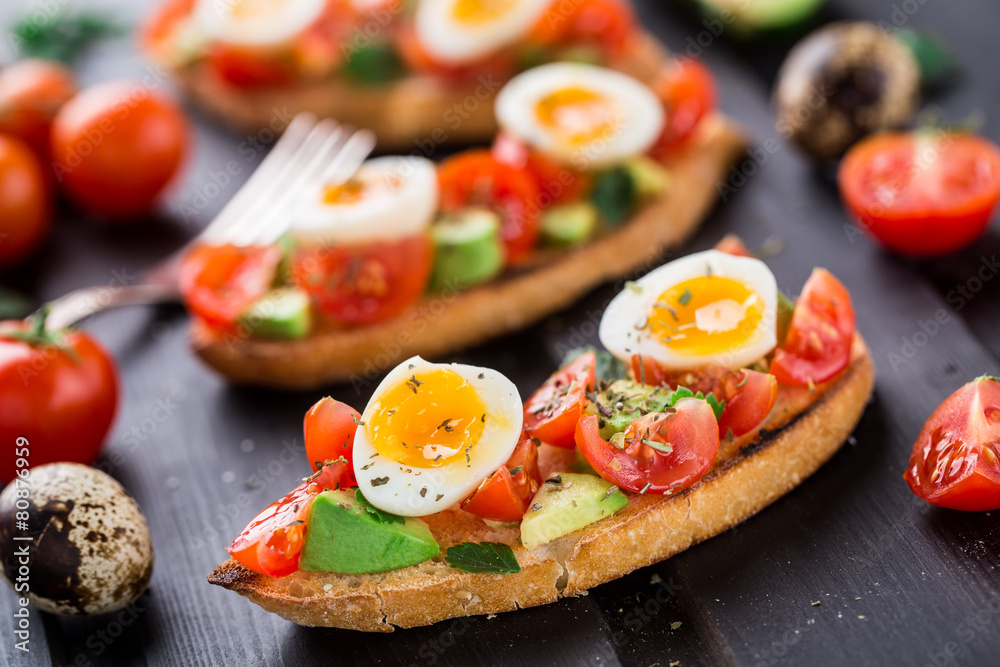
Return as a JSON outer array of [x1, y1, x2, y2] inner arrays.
[[365, 369, 486, 468]]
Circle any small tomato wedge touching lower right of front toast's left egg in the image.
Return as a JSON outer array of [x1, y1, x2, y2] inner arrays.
[[462, 438, 542, 522]]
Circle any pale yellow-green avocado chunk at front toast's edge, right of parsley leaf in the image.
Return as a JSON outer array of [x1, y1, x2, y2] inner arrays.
[[521, 472, 628, 549]]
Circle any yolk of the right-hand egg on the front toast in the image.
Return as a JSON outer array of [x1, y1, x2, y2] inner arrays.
[[645, 276, 764, 355]]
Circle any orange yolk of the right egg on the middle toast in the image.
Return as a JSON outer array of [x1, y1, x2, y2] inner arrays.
[[535, 87, 619, 146]]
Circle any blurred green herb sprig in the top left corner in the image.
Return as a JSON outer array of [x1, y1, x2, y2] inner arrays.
[[10, 12, 125, 63]]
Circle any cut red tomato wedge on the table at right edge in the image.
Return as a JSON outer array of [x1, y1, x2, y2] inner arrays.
[[903, 377, 1000, 512]]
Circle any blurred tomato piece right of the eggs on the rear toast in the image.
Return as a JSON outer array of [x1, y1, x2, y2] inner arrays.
[[530, 0, 635, 58]]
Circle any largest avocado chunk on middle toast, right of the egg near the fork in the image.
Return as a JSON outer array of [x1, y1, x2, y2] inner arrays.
[[430, 208, 504, 292]]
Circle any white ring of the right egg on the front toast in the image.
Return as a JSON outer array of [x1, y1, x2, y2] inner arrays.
[[598, 250, 778, 370]]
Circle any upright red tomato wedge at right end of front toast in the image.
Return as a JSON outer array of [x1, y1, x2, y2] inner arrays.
[[771, 269, 854, 386]]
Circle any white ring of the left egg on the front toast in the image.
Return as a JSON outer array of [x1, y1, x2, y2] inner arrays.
[[354, 357, 524, 516]]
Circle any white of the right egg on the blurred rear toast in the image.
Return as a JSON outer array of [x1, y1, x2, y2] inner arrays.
[[414, 0, 554, 65]]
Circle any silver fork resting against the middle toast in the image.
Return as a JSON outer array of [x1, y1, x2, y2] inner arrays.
[[45, 113, 375, 331]]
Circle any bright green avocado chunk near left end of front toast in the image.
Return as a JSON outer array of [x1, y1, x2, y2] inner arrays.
[[299, 490, 441, 574]]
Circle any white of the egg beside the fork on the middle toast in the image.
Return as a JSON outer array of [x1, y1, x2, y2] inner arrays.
[[289, 156, 440, 247]]
